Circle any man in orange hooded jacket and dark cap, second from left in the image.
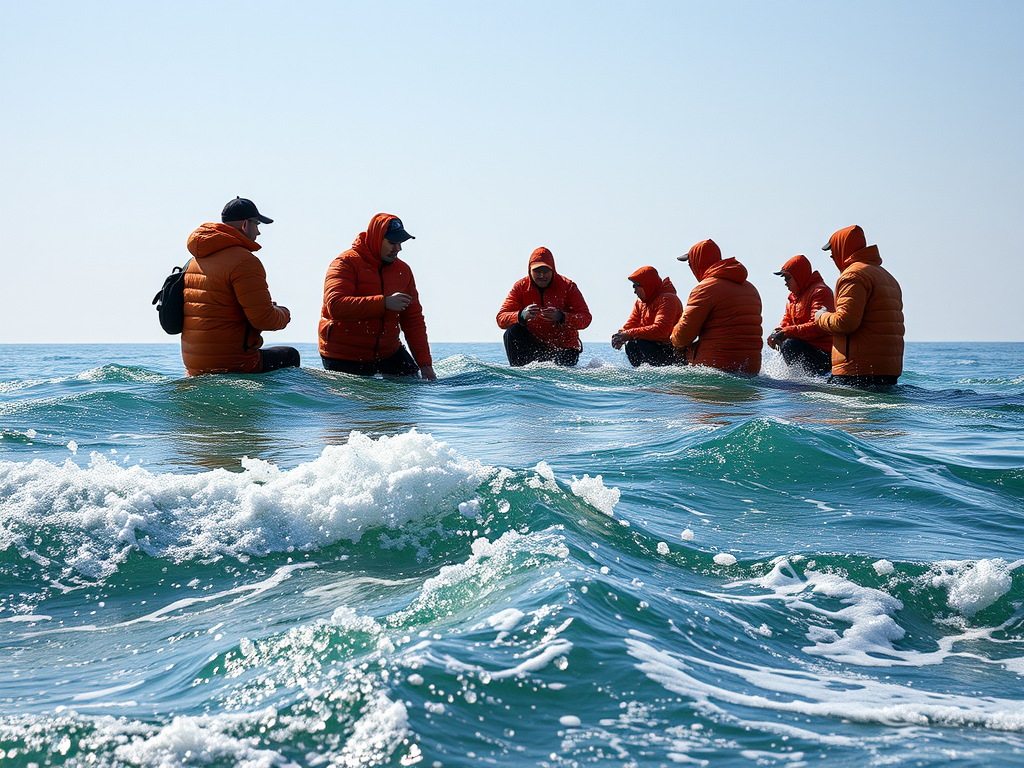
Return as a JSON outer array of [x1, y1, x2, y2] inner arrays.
[[318, 213, 435, 380]]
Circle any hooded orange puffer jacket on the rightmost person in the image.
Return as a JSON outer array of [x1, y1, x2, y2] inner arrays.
[[817, 225, 905, 376]]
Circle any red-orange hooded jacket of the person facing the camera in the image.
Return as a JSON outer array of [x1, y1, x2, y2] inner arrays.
[[497, 248, 593, 349]]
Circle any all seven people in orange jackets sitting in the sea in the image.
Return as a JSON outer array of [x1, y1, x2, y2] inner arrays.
[[181, 198, 904, 386]]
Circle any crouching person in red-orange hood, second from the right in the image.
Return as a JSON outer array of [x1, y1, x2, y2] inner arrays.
[[768, 256, 836, 376]]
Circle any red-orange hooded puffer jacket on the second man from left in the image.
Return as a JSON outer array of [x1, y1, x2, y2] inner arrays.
[[318, 213, 433, 368]]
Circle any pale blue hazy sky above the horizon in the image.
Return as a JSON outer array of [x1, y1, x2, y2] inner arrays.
[[0, 0, 1024, 342]]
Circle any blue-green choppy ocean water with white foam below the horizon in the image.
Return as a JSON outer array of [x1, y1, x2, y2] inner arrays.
[[0, 344, 1024, 768]]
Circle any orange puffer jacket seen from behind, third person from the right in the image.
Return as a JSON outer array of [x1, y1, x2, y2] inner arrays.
[[672, 240, 763, 374]]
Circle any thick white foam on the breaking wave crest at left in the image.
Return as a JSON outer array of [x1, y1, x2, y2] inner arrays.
[[0, 430, 495, 579]]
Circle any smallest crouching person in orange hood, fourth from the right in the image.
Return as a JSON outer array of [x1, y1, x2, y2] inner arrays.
[[611, 266, 683, 368]]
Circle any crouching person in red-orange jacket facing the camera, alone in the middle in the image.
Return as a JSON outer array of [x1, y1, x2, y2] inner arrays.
[[497, 248, 592, 366]]
